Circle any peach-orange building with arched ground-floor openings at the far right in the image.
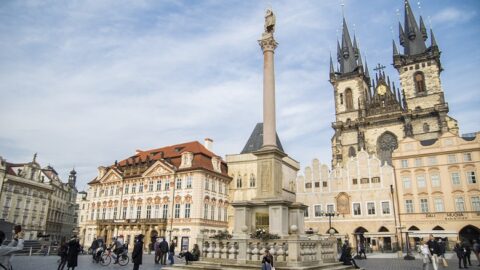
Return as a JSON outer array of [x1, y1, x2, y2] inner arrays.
[[393, 132, 480, 247]]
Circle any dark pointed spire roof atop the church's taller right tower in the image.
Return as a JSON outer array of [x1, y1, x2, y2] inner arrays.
[[400, 0, 427, 55]]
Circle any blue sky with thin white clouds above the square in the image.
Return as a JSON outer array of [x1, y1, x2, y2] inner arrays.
[[0, 0, 480, 189]]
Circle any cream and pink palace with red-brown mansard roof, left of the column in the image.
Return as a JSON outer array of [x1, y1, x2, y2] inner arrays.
[[78, 139, 231, 249]]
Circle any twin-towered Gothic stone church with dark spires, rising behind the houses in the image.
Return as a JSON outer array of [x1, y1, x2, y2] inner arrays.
[[330, 1, 458, 165]]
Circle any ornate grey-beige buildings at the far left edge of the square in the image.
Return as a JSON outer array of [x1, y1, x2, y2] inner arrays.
[[0, 154, 77, 241]]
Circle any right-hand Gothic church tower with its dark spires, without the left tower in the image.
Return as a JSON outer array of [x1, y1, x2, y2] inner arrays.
[[393, 1, 458, 140]]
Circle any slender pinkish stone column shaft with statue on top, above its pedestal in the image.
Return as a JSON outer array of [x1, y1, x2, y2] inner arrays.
[[258, 9, 278, 148]]
